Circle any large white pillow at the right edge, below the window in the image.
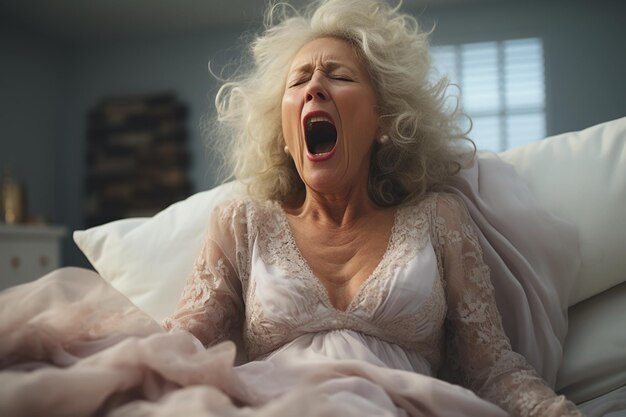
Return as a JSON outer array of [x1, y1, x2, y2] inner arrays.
[[500, 117, 626, 306]]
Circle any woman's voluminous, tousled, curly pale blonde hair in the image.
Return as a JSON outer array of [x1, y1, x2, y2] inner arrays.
[[211, 0, 468, 206]]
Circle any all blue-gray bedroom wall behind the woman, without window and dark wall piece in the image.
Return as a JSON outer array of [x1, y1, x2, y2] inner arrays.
[[0, 0, 626, 266]]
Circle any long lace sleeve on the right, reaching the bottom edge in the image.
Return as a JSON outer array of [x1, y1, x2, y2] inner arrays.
[[435, 195, 582, 417]]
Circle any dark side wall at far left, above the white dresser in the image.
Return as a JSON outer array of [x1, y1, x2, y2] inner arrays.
[[0, 19, 67, 222]]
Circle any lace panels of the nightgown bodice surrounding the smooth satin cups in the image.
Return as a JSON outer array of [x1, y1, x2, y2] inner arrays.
[[245, 198, 447, 369]]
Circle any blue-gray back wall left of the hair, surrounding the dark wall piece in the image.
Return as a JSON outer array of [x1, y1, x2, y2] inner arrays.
[[59, 33, 244, 265]]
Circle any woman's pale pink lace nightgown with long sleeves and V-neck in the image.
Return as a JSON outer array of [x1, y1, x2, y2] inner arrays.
[[165, 194, 579, 416]]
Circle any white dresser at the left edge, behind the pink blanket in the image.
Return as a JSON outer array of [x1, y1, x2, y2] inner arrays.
[[0, 223, 66, 289]]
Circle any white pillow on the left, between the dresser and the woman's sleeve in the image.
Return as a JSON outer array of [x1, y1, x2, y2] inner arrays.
[[73, 182, 243, 322]]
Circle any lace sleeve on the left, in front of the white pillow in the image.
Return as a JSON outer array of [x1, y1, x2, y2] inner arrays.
[[163, 202, 244, 346]]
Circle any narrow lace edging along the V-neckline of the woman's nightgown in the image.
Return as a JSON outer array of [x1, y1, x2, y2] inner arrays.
[[275, 202, 401, 313]]
